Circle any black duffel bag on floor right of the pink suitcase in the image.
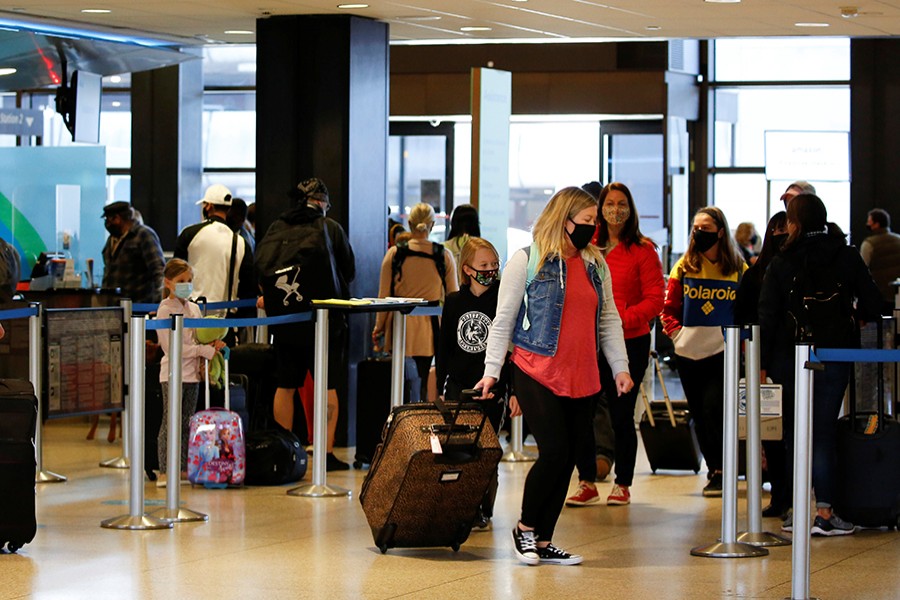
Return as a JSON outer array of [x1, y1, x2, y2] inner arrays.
[[244, 429, 309, 485]]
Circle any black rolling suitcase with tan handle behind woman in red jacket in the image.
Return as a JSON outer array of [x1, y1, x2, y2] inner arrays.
[[640, 352, 703, 473]]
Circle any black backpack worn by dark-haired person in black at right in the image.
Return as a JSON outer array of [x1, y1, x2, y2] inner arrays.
[[788, 252, 856, 348]]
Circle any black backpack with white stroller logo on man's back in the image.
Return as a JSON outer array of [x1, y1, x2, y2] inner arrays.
[[255, 218, 341, 316]]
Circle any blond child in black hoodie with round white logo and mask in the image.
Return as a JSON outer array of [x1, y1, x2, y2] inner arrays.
[[435, 237, 506, 531]]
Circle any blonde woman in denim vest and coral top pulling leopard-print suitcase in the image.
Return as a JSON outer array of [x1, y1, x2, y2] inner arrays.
[[475, 187, 634, 565]]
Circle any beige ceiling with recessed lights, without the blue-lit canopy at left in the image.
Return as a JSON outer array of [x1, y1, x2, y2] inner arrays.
[[0, 0, 900, 45]]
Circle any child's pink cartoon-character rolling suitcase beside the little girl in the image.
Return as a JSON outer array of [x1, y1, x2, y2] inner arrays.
[[187, 358, 247, 488]]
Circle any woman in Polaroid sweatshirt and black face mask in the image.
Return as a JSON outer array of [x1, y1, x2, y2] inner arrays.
[[660, 206, 747, 496]]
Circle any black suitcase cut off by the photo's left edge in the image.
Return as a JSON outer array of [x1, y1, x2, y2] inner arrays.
[[0, 379, 37, 552]]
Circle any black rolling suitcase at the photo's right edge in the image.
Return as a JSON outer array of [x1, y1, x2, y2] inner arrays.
[[834, 319, 900, 528]]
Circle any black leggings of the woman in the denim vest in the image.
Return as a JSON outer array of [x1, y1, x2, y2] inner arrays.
[[512, 365, 593, 542]]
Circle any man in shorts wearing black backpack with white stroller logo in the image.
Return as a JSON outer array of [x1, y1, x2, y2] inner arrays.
[[256, 177, 356, 471]]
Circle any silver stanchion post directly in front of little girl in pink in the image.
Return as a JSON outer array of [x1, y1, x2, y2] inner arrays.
[[150, 315, 209, 523]]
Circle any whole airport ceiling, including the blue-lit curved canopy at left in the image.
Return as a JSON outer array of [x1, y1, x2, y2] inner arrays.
[[0, 0, 900, 91]]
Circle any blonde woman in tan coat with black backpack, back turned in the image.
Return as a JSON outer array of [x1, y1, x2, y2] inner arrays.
[[372, 202, 459, 399]]
